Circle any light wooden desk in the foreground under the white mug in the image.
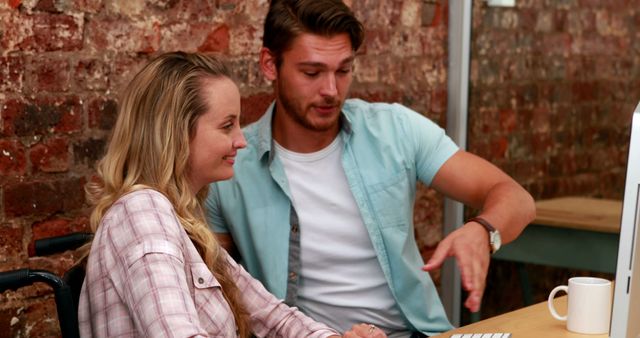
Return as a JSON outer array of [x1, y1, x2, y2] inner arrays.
[[432, 296, 609, 338]]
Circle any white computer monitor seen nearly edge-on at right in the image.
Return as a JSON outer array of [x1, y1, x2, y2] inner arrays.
[[609, 103, 640, 338]]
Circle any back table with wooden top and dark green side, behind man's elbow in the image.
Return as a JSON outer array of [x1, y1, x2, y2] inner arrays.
[[493, 197, 622, 273]]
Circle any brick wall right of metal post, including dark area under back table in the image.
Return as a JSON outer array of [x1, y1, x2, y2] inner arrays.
[[470, 0, 640, 318]]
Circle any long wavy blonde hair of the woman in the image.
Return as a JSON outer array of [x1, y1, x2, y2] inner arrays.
[[84, 52, 250, 338]]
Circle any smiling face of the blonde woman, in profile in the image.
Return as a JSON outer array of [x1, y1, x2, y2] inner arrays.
[[189, 77, 247, 193]]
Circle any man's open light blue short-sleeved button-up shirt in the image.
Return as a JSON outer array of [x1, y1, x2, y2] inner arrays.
[[206, 99, 458, 335]]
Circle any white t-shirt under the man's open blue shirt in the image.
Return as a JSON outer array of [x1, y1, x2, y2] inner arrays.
[[274, 136, 409, 337]]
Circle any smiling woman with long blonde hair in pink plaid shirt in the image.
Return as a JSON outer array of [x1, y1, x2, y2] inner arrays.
[[79, 53, 377, 337]]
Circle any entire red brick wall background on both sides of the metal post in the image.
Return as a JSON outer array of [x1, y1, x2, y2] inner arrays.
[[0, 0, 640, 337]]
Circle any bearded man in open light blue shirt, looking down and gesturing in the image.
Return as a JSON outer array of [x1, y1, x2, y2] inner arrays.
[[207, 0, 535, 337]]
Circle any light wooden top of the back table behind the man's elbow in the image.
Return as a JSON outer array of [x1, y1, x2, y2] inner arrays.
[[533, 196, 622, 233]]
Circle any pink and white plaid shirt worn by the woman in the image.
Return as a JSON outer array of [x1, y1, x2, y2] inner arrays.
[[78, 189, 337, 338]]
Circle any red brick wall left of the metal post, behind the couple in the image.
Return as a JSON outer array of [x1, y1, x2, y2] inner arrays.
[[0, 0, 447, 337]]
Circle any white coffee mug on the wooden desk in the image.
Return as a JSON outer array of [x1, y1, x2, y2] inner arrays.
[[547, 277, 611, 334]]
